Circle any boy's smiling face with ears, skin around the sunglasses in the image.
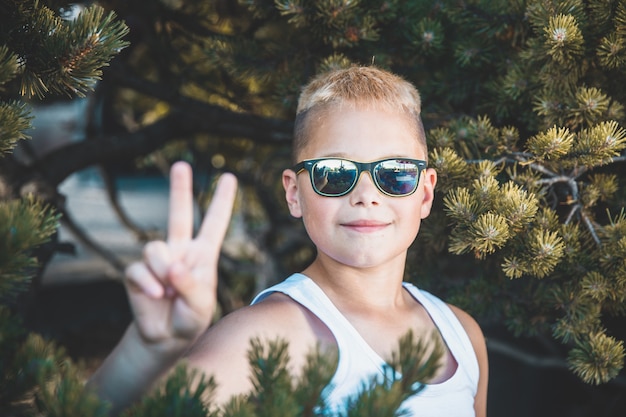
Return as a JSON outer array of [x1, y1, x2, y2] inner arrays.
[[283, 107, 437, 268]]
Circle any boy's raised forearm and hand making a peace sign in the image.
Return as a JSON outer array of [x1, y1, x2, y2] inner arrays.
[[87, 163, 237, 414]]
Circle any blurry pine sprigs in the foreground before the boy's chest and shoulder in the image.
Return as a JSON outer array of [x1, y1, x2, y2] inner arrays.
[[122, 332, 443, 417]]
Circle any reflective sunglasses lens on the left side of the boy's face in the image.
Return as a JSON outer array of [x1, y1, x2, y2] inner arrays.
[[311, 159, 357, 196]]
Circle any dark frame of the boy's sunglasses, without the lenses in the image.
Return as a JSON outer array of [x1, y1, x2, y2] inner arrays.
[[292, 158, 427, 197]]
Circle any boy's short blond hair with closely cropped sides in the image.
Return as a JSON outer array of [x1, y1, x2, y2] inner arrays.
[[293, 66, 426, 159]]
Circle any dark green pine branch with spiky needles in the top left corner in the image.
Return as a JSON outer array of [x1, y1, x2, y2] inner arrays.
[[2, 1, 128, 98]]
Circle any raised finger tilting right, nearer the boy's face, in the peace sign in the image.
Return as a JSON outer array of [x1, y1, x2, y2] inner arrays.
[[198, 173, 237, 246]]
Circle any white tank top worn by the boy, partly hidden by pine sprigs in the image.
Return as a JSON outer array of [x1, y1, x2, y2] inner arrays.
[[252, 274, 479, 417]]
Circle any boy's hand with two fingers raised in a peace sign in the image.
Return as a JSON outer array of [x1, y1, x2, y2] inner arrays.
[[126, 162, 237, 352]]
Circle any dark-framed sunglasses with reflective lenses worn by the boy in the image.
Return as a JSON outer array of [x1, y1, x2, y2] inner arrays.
[[292, 158, 426, 197]]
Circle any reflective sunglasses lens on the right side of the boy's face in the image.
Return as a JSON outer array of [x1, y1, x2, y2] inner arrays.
[[374, 159, 419, 195]]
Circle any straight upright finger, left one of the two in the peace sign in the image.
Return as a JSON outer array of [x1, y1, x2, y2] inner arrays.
[[167, 161, 193, 243]]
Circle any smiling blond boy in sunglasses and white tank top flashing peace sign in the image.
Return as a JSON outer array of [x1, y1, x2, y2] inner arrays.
[[89, 67, 487, 417]]
